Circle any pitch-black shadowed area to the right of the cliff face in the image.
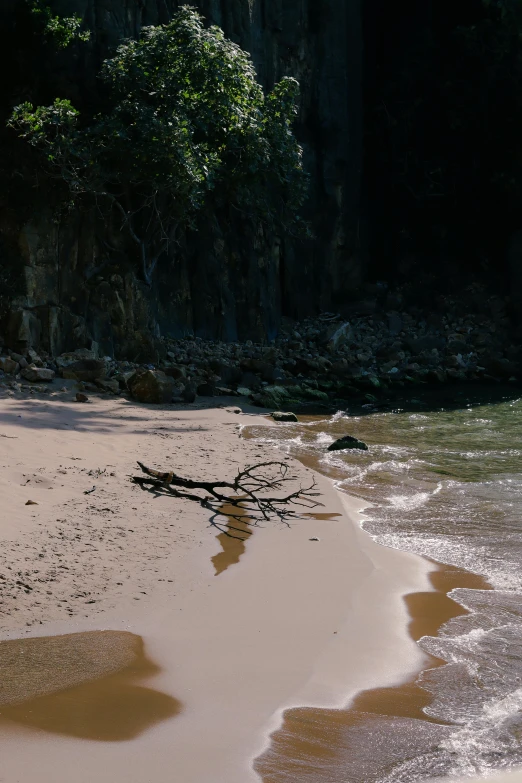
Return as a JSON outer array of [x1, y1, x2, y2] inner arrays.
[[363, 0, 522, 304]]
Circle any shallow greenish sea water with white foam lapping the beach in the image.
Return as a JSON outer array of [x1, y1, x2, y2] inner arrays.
[[249, 396, 522, 783]]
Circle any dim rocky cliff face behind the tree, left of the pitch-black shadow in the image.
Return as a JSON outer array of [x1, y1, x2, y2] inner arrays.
[[0, 0, 362, 360]]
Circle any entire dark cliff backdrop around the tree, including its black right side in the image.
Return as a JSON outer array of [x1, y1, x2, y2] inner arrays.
[[0, 0, 522, 361]]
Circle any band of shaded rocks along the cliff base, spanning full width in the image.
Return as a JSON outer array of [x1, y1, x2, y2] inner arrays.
[[0, 290, 522, 411]]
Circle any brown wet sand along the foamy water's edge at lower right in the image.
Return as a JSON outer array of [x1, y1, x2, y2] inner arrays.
[[255, 563, 491, 783]]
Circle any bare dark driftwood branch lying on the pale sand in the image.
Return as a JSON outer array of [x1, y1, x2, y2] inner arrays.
[[132, 462, 322, 537]]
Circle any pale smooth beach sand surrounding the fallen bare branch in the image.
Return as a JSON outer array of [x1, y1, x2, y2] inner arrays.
[[0, 391, 440, 783]]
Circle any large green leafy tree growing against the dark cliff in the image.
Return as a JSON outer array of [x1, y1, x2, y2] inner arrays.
[[9, 7, 307, 284]]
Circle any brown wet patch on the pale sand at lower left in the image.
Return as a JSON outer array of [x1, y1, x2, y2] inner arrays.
[[0, 631, 181, 742]]
